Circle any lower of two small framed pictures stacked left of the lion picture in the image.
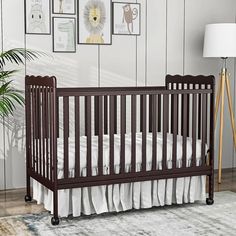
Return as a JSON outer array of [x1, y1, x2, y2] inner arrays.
[[52, 17, 76, 52]]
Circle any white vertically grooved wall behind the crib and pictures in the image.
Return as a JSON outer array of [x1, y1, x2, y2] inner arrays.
[[0, 0, 236, 189]]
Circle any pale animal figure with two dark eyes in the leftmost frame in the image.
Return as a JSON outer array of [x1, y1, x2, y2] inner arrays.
[[28, 3, 47, 33]]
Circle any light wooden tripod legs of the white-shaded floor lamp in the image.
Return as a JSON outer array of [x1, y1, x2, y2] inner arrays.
[[215, 66, 236, 184]]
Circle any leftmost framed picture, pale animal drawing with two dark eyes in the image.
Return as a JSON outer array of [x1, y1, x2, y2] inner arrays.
[[25, 0, 51, 34]]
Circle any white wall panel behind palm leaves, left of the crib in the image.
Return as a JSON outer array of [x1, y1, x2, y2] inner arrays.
[[2, 0, 25, 189]]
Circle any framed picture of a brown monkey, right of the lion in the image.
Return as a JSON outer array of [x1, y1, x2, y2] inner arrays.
[[113, 2, 141, 35]]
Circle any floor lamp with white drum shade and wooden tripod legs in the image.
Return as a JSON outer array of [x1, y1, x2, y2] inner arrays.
[[203, 23, 236, 183]]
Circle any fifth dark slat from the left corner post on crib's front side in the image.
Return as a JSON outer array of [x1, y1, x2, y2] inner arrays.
[[109, 96, 115, 175]]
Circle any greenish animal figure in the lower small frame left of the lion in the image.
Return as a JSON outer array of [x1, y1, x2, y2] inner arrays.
[[58, 20, 75, 51]]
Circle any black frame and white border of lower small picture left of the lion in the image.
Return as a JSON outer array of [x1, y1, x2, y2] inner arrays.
[[52, 17, 77, 53]]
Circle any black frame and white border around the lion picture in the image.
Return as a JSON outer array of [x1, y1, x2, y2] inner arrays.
[[77, 0, 113, 45]]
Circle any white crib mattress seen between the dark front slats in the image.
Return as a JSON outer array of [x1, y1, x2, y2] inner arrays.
[[58, 132, 207, 170]]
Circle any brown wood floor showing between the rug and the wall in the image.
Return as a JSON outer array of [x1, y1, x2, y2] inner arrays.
[[0, 169, 236, 217]]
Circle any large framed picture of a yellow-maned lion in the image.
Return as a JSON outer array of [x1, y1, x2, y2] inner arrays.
[[77, 0, 112, 45]]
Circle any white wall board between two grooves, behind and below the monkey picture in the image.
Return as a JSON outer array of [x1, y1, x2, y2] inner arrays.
[[100, 0, 136, 86]]
